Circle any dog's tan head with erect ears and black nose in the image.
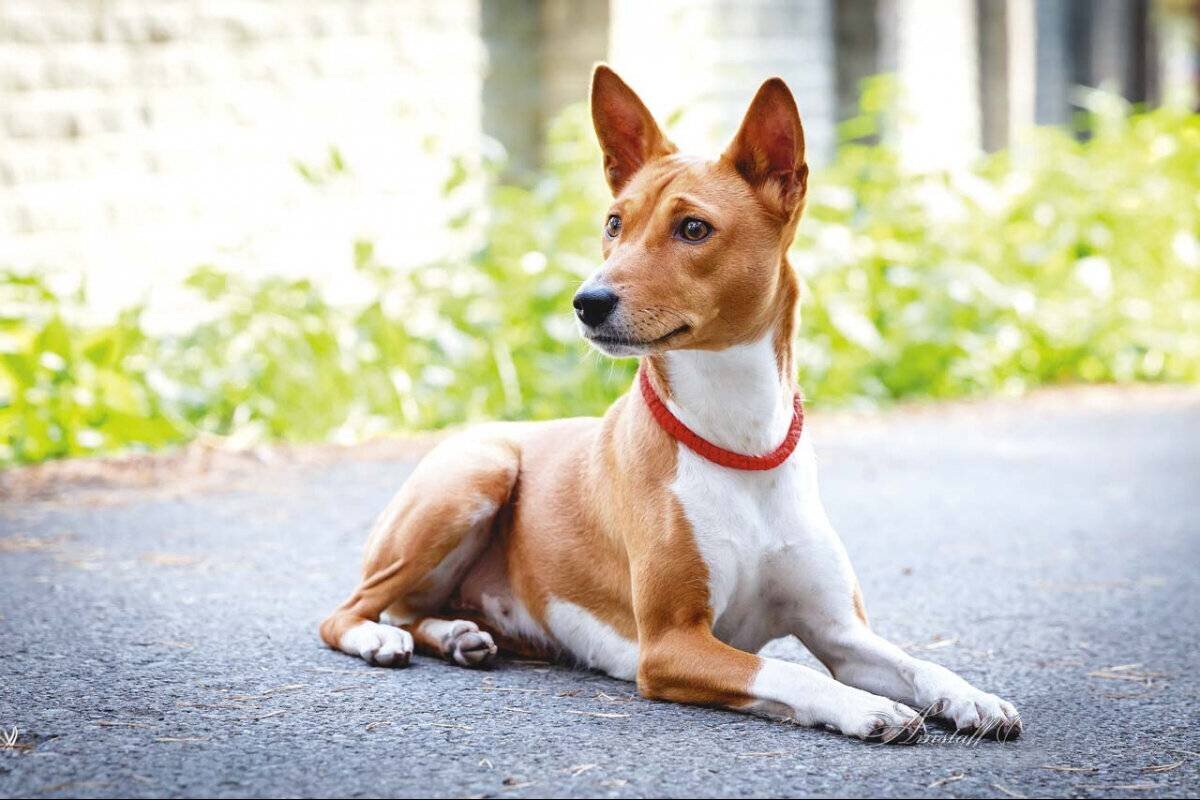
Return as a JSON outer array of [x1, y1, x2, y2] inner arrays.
[[574, 65, 808, 356]]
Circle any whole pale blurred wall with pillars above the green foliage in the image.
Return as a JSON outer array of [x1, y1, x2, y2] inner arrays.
[[0, 0, 1180, 305]]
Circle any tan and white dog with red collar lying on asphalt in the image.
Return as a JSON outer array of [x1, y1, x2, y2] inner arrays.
[[320, 65, 1021, 742]]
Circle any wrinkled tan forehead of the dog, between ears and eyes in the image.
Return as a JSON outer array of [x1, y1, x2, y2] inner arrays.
[[613, 155, 754, 217]]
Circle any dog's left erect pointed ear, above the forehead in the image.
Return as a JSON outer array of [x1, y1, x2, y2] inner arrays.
[[592, 64, 676, 194]]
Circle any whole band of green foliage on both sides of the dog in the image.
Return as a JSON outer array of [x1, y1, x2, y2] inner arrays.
[[0, 85, 1200, 464]]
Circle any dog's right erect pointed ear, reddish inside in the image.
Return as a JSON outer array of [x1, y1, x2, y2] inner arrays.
[[722, 78, 809, 218]]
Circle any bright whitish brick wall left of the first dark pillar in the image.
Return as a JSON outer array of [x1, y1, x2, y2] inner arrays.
[[0, 0, 484, 311]]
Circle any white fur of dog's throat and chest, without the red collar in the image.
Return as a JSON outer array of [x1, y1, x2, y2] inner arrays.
[[667, 336, 852, 650]]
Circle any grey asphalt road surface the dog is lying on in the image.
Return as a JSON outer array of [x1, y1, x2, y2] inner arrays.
[[0, 390, 1200, 798]]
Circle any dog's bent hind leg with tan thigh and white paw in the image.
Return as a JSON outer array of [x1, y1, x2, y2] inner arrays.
[[320, 434, 520, 667]]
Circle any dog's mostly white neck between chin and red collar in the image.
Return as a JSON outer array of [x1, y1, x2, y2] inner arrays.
[[655, 330, 796, 455]]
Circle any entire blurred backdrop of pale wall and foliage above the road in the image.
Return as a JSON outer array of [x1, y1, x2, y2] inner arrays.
[[0, 0, 1200, 464]]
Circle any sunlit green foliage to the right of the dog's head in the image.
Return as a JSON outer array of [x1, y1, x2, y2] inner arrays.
[[793, 86, 1200, 401]]
